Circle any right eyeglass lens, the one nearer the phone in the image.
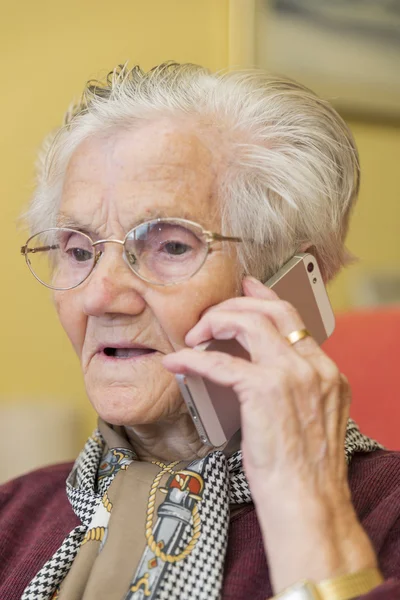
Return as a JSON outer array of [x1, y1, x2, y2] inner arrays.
[[125, 220, 208, 284]]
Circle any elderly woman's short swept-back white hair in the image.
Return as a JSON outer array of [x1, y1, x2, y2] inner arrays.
[[26, 63, 359, 280]]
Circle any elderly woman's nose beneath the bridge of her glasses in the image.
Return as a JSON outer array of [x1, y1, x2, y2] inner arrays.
[[82, 244, 147, 317]]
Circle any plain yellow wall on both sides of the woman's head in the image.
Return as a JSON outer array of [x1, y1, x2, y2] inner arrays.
[[0, 0, 400, 446]]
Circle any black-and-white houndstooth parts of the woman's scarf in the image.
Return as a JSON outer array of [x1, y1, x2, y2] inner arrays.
[[21, 419, 382, 600]]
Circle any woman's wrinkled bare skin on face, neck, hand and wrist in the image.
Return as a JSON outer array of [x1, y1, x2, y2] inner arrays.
[[55, 119, 376, 592]]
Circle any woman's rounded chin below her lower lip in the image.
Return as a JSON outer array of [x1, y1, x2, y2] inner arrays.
[[86, 373, 183, 427]]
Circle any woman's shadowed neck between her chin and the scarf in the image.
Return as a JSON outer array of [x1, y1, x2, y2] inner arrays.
[[125, 412, 211, 462]]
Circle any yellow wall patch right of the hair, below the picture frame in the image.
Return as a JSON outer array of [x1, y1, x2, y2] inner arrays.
[[329, 121, 400, 309]]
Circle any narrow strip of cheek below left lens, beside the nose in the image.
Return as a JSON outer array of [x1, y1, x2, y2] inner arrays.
[[53, 291, 87, 357]]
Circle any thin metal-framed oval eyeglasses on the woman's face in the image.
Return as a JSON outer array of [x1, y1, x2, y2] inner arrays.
[[21, 218, 242, 290]]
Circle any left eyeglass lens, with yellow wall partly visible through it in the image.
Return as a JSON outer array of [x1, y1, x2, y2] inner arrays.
[[26, 229, 94, 290]]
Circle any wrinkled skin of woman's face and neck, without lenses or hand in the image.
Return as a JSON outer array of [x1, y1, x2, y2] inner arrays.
[[54, 121, 241, 459]]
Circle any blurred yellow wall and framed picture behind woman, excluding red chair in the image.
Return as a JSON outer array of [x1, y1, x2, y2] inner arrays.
[[0, 0, 400, 482]]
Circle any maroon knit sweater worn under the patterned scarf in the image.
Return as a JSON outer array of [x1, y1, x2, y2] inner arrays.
[[0, 450, 400, 600]]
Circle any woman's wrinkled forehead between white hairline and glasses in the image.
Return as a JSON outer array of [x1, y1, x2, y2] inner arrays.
[[60, 119, 221, 230]]
